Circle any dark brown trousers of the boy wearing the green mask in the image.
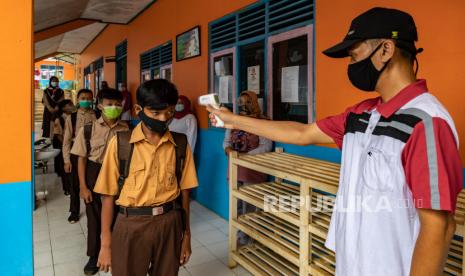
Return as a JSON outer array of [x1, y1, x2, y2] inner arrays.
[[86, 160, 102, 257]]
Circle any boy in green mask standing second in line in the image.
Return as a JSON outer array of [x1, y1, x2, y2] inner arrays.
[[71, 88, 129, 275]]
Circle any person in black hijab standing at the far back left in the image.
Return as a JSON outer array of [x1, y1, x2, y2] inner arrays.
[[42, 76, 65, 137]]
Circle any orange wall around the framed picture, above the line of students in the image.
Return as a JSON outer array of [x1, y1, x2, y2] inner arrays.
[[81, 0, 255, 128]]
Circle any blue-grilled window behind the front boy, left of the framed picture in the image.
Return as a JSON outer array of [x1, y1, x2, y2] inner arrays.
[[140, 41, 173, 83]]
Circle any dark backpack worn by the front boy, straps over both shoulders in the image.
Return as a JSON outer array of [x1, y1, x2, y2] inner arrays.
[[116, 130, 187, 230]]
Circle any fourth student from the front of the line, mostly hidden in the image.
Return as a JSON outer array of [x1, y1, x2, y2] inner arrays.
[[52, 100, 76, 196]]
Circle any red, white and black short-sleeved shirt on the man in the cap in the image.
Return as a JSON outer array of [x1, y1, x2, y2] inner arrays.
[[317, 80, 463, 276]]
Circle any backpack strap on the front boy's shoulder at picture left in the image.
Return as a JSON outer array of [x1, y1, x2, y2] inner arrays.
[[116, 130, 134, 192]]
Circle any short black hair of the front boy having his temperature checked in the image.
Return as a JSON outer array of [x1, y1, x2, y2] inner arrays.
[[136, 79, 178, 110]]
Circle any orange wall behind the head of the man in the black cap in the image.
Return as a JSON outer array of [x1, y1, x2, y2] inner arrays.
[[315, 0, 465, 160]]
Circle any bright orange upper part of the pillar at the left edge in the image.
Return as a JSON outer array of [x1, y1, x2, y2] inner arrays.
[[0, 0, 33, 184]]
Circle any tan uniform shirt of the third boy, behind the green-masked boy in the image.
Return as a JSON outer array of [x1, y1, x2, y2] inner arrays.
[[63, 108, 97, 163]]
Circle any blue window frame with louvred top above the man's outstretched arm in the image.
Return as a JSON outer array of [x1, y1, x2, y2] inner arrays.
[[209, 0, 315, 121]]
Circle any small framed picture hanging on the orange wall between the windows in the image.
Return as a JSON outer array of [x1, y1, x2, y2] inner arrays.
[[176, 26, 200, 61]]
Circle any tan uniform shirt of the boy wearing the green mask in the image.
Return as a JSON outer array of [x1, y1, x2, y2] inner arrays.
[[71, 117, 129, 164]]
